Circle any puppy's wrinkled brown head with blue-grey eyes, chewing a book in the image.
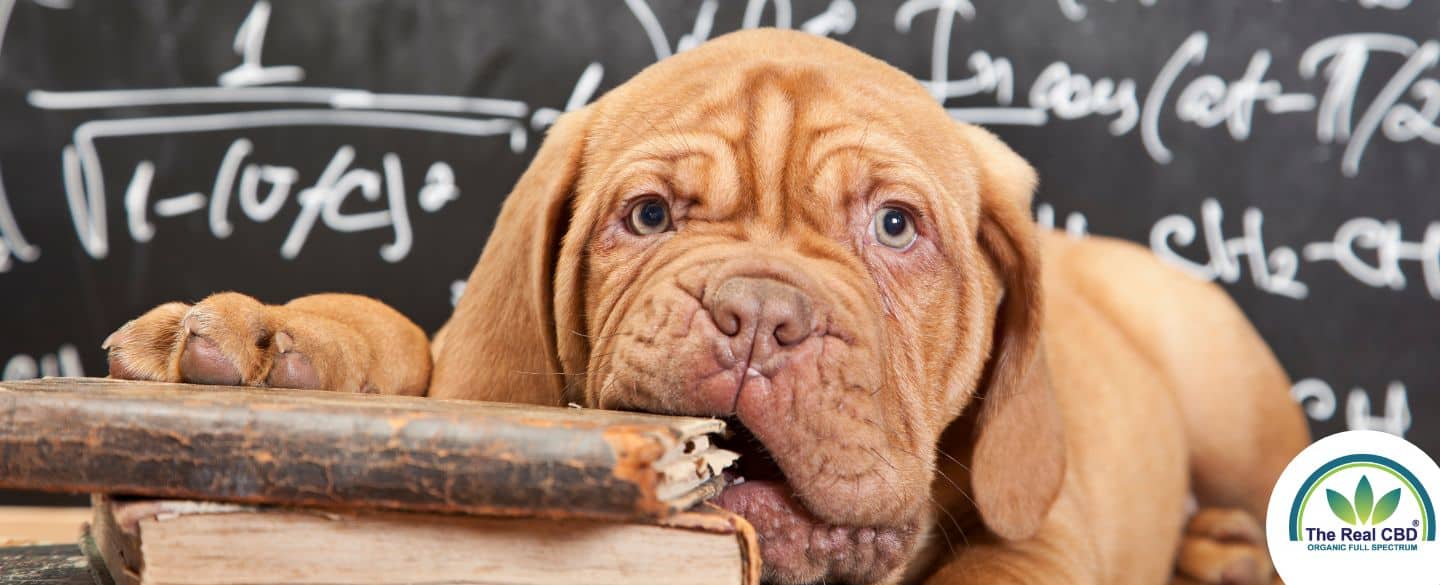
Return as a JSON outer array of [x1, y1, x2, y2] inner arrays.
[[461, 30, 1063, 582]]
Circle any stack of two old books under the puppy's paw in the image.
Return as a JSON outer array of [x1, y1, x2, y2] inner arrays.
[[0, 379, 760, 585]]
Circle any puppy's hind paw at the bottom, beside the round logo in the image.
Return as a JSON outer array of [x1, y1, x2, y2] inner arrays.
[[1175, 507, 1274, 585]]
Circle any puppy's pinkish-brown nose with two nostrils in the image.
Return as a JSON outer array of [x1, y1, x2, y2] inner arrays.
[[706, 277, 815, 346]]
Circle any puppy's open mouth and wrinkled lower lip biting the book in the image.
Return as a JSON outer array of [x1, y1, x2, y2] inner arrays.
[[714, 418, 913, 584]]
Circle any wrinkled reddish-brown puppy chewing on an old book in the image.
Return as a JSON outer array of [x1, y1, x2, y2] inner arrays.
[[107, 30, 1308, 584]]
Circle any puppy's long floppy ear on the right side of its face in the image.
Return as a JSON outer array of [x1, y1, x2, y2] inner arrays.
[[960, 124, 1066, 540]]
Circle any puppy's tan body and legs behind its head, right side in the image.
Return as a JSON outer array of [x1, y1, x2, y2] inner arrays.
[[935, 232, 1308, 584]]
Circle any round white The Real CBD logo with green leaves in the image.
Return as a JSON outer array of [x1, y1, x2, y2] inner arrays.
[[1266, 431, 1440, 585]]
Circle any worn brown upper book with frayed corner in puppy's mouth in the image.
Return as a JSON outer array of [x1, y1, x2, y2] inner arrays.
[[0, 378, 736, 520]]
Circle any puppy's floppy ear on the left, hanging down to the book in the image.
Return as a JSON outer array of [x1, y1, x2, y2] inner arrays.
[[429, 108, 590, 405]]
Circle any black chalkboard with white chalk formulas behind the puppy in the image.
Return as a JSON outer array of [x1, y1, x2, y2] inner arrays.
[[0, 0, 1440, 475]]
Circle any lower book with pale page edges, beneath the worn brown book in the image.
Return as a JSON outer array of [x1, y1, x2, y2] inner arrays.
[[91, 497, 760, 585]]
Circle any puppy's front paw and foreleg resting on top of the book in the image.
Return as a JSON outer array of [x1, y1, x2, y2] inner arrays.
[[104, 293, 431, 395]]
